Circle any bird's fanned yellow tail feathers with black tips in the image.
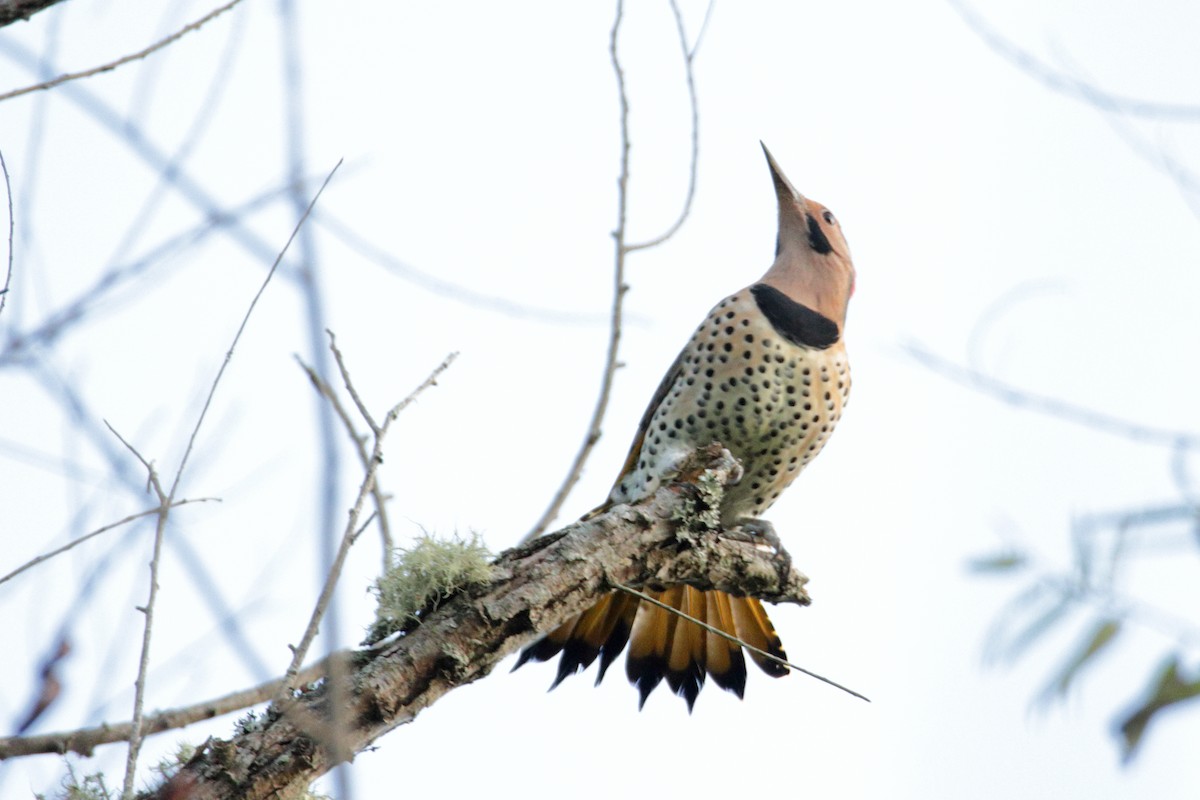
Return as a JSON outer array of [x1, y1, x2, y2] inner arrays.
[[514, 587, 787, 710]]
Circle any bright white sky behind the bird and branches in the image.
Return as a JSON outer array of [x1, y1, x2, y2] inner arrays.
[[0, 0, 1200, 799]]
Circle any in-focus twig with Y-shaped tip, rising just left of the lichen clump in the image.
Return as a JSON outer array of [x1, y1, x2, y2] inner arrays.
[[280, 350, 458, 699]]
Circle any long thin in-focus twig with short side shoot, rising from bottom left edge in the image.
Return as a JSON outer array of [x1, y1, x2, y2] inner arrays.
[[114, 161, 342, 796]]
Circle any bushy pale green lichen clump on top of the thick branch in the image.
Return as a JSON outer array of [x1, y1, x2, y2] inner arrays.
[[364, 533, 492, 644]]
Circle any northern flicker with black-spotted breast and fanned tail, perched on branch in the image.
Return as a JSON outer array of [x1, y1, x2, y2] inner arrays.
[[517, 145, 854, 710]]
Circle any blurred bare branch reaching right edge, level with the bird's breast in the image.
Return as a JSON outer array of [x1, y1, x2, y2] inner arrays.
[[904, 343, 1200, 449]]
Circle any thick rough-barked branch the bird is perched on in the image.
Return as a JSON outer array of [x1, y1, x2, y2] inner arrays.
[[147, 446, 809, 800]]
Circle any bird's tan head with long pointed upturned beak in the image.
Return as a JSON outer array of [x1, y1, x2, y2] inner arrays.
[[762, 145, 854, 330]]
